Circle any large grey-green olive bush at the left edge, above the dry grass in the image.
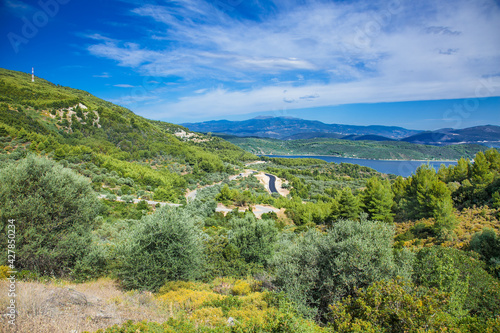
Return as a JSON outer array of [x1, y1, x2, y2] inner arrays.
[[0, 155, 100, 276]]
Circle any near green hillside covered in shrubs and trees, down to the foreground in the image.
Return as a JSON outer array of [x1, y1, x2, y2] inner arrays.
[[0, 66, 500, 333]]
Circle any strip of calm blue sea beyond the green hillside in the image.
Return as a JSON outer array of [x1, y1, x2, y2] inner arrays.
[[266, 155, 457, 177]]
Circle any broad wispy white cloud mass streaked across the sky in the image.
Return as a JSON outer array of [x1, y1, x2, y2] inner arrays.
[[84, 0, 500, 118]]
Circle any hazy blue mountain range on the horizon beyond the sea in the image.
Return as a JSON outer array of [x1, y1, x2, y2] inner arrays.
[[182, 117, 500, 147]]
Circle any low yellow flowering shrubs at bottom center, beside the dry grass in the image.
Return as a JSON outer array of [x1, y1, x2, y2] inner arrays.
[[148, 277, 321, 333]]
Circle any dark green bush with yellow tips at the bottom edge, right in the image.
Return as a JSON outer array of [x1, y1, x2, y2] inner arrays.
[[328, 279, 460, 333]]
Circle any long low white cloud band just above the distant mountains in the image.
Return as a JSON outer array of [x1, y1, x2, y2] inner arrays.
[[140, 77, 500, 119]]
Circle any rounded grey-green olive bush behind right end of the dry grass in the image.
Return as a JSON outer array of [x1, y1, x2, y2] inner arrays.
[[114, 206, 202, 291]]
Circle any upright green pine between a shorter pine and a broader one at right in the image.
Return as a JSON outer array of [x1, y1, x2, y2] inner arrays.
[[363, 177, 394, 222]]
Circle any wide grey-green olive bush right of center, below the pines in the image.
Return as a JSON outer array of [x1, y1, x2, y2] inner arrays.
[[272, 220, 394, 319]]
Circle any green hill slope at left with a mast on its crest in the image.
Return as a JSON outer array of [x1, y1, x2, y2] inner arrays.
[[0, 69, 256, 201]]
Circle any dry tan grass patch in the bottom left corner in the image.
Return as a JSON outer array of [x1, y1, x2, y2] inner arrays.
[[0, 279, 168, 333]]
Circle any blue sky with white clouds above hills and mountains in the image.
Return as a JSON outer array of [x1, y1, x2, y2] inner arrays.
[[0, 0, 500, 129]]
